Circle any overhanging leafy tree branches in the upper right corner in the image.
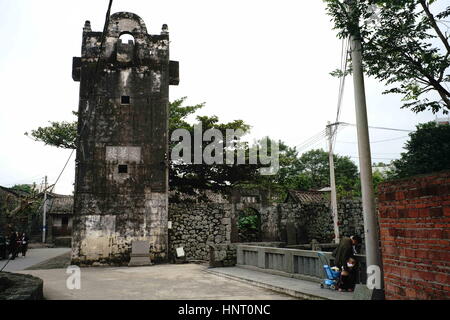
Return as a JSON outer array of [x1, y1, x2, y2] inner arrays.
[[324, 0, 450, 113]]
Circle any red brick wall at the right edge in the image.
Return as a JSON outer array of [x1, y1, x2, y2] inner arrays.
[[378, 172, 450, 299]]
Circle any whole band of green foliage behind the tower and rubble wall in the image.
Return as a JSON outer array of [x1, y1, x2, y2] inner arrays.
[[26, 98, 368, 201]]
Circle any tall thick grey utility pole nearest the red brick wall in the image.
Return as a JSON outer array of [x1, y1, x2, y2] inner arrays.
[[346, 0, 384, 290]]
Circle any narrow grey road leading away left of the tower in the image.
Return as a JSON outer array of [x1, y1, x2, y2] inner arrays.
[[0, 248, 70, 272]]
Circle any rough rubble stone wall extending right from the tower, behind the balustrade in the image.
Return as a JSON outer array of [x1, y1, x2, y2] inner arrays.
[[169, 200, 364, 264]]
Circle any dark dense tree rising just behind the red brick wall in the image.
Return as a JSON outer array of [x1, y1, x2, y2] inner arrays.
[[393, 121, 450, 178]]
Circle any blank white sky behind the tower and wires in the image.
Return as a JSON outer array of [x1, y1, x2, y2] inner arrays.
[[0, 0, 444, 194]]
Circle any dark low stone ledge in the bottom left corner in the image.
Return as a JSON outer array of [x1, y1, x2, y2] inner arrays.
[[0, 272, 44, 300]]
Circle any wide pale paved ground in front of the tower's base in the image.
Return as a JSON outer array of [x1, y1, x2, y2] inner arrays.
[[20, 264, 295, 300]]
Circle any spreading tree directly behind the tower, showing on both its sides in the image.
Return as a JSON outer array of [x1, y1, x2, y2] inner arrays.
[[25, 97, 258, 192]]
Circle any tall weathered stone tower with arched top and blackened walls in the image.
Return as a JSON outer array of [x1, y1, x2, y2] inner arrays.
[[72, 12, 178, 264]]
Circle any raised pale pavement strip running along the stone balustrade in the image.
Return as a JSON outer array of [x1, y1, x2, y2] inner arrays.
[[208, 267, 353, 300]]
